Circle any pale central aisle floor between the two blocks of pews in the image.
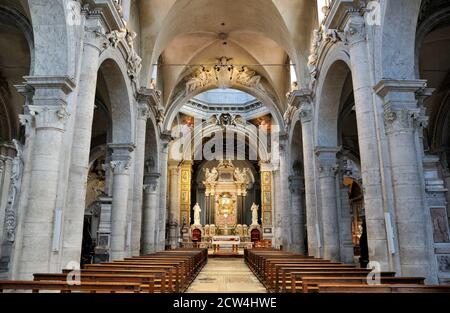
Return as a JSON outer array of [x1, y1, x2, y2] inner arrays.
[[187, 258, 267, 293]]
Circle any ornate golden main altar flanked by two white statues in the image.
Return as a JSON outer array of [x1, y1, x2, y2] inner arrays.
[[185, 160, 262, 253]]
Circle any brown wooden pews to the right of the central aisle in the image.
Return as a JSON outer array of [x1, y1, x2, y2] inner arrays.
[[244, 248, 450, 293]]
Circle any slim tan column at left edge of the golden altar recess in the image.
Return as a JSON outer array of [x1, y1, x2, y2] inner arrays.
[[169, 162, 180, 249]]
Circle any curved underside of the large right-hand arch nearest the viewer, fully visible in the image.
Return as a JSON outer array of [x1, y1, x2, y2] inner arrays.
[[315, 48, 351, 147]]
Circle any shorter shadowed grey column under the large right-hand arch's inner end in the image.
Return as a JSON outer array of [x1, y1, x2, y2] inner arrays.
[[315, 147, 340, 261]]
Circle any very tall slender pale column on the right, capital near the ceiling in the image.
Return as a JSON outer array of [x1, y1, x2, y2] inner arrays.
[[345, 14, 393, 270]]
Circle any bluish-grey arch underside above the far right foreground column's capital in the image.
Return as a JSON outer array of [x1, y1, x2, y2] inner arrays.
[[377, 0, 422, 79]]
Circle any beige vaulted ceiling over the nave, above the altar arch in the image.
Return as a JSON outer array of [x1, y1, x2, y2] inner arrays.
[[137, 0, 317, 111]]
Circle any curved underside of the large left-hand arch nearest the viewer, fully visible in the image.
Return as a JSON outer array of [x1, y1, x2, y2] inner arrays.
[[99, 55, 135, 143]]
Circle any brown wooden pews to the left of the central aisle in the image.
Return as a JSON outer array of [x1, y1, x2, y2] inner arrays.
[[0, 249, 208, 293]]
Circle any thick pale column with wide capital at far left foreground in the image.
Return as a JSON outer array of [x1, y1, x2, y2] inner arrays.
[[17, 76, 75, 280]]
